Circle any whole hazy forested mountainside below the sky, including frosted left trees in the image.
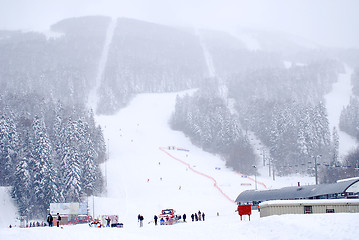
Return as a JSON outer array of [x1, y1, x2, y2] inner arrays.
[[0, 16, 359, 219]]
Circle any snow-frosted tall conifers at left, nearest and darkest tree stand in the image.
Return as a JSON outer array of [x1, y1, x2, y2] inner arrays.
[[0, 94, 106, 217]]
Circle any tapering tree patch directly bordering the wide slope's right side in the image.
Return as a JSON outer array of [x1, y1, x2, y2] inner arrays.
[[171, 81, 255, 174]]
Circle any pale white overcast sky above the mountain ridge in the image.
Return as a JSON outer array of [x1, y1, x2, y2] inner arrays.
[[0, 0, 359, 48]]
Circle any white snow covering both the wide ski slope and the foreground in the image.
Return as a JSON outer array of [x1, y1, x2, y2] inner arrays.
[[0, 90, 359, 240]]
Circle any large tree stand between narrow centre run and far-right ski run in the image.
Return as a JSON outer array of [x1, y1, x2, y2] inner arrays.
[[229, 60, 342, 174]]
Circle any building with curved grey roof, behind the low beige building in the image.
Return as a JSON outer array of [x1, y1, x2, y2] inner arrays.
[[236, 178, 359, 206]]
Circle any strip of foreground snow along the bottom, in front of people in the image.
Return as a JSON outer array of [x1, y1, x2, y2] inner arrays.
[[0, 213, 359, 240]]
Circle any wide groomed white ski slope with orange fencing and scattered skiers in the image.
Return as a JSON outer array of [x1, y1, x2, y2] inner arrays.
[[90, 92, 316, 226]]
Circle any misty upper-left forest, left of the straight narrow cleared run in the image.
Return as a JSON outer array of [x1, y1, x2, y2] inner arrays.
[[0, 17, 110, 109]]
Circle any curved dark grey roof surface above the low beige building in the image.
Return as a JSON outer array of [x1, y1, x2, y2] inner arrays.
[[236, 179, 359, 202]]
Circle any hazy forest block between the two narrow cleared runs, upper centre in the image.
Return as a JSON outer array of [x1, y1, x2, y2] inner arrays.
[[99, 18, 210, 114]]
